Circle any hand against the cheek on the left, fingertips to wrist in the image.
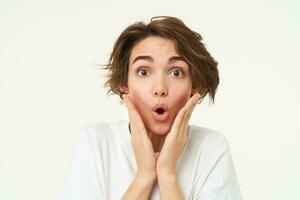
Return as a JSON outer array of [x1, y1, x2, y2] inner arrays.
[[122, 94, 156, 179]]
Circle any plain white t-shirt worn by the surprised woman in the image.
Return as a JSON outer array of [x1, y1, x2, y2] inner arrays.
[[60, 120, 242, 200]]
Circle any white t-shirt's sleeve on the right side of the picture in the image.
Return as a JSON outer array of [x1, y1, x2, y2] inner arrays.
[[194, 136, 242, 200]]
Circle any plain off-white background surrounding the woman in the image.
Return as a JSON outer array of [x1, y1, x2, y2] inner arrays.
[[0, 0, 300, 200]]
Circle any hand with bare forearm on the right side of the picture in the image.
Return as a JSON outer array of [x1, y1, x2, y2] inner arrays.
[[156, 93, 200, 200]]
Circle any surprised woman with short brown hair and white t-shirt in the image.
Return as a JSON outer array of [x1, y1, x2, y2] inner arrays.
[[62, 17, 242, 200]]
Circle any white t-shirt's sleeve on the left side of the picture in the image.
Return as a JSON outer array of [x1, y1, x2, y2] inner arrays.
[[59, 128, 101, 200]]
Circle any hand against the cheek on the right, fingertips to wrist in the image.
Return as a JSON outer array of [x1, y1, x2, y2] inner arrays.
[[156, 93, 200, 175]]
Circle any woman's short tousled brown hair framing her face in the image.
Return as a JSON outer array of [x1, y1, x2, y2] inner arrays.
[[102, 16, 219, 103]]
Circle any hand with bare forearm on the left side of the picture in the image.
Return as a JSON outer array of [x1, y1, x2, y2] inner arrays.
[[122, 95, 156, 200]]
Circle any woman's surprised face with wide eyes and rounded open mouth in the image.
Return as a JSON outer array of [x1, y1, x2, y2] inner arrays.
[[125, 36, 192, 135]]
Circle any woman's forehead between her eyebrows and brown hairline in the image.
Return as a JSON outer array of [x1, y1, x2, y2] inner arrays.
[[129, 36, 178, 63]]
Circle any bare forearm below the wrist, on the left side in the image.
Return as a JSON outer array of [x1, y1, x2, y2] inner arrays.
[[122, 175, 155, 200]]
